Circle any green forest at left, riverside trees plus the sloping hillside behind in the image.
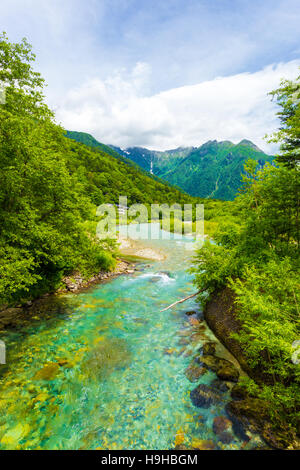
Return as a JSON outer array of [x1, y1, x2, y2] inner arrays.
[[0, 34, 192, 307]]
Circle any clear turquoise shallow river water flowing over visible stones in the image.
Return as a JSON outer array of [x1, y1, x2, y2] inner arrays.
[[0, 227, 262, 449]]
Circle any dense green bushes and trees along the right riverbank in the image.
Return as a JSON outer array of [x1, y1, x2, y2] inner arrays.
[[195, 75, 300, 439]]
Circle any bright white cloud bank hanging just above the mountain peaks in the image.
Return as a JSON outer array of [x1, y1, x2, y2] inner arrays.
[[56, 61, 299, 152]]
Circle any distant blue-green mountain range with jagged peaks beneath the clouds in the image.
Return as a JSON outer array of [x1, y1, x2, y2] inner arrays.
[[67, 131, 274, 200]]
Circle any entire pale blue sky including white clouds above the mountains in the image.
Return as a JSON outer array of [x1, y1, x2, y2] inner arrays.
[[0, 0, 300, 151]]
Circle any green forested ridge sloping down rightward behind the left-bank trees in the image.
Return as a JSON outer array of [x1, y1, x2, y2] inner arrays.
[[66, 131, 193, 205]]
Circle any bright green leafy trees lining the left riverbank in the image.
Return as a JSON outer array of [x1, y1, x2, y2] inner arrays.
[[0, 34, 119, 305]]
